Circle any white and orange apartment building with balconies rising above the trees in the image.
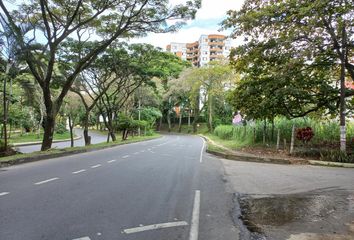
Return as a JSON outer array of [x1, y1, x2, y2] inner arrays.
[[166, 34, 231, 67]]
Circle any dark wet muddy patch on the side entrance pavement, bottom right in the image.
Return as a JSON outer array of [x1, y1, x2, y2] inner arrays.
[[238, 189, 354, 240]]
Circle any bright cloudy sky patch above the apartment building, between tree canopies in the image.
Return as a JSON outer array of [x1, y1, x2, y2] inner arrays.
[[130, 0, 244, 49]]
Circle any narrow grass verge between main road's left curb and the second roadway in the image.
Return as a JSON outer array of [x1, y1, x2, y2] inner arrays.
[[0, 134, 161, 166]]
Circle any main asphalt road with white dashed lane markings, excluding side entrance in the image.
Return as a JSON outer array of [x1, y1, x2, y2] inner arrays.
[[0, 135, 239, 240]]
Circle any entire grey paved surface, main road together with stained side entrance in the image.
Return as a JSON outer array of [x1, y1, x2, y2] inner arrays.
[[0, 135, 354, 240]]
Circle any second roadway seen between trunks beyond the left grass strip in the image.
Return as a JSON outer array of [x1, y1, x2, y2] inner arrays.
[[16, 129, 107, 153]]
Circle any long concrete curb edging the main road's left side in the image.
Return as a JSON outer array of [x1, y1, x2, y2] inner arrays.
[[0, 136, 163, 168]]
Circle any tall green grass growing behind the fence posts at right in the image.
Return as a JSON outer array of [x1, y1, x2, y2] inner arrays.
[[214, 118, 354, 147]]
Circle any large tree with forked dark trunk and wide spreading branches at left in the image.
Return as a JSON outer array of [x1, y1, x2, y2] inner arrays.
[[0, 0, 201, 150]]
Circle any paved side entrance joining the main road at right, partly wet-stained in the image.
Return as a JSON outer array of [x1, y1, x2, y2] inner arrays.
[[221, 156, 354, 240]]
